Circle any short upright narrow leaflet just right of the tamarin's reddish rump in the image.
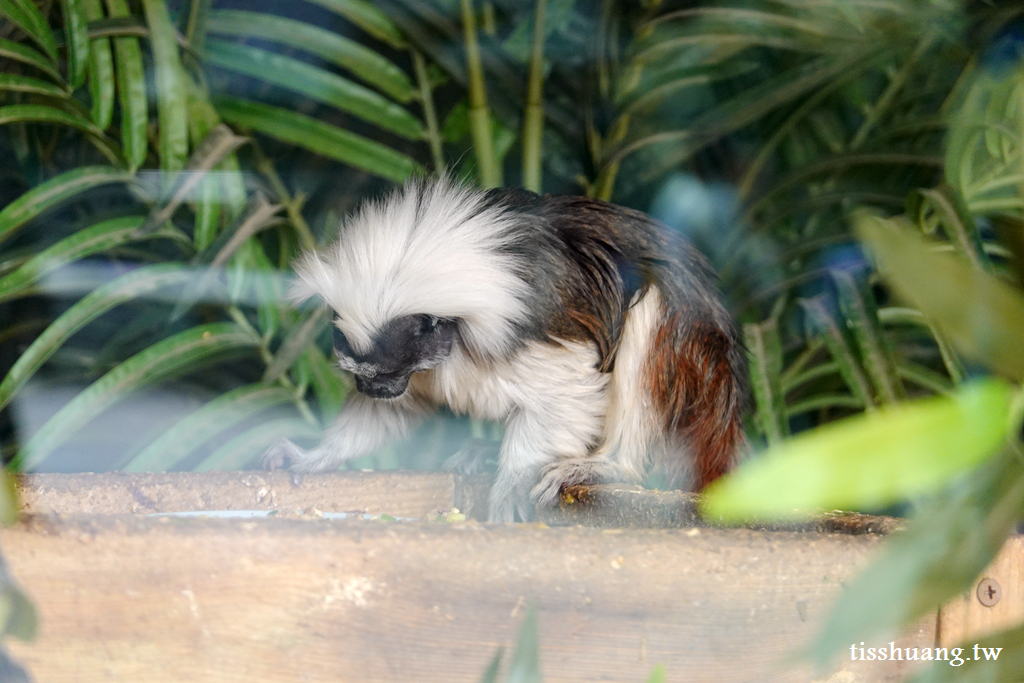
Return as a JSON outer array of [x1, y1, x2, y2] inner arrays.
[[743, 318, 790, 444]]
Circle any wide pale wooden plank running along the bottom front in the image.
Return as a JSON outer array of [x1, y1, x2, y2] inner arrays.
[[0, 516, 934, 683]]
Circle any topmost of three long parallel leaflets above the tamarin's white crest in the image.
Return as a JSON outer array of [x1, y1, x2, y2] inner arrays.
[[209, 9, 415, 102]]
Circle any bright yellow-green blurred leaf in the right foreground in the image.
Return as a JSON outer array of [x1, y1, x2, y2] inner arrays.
[[706, 380, 1014, 520]]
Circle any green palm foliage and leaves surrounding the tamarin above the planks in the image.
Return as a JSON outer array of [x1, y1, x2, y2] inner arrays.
[[0, 0, 1024, 669]]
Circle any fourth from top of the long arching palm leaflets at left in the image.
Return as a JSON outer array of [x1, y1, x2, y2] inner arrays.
[[12, 323, 259, 470]]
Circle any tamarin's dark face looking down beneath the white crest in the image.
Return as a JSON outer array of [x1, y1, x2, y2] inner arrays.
[[334, 314, 458, 398]]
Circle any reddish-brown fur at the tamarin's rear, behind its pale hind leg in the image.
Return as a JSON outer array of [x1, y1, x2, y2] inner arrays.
[[647, 312, 745, 490]]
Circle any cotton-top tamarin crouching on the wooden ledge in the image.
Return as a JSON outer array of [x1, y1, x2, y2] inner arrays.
[[263, 179, 745, 521]]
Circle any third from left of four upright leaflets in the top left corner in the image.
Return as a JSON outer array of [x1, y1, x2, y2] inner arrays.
[[106, 0, 150, 170]]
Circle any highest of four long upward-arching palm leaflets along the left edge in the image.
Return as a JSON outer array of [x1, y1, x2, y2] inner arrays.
[[0, 216, 143, 302]]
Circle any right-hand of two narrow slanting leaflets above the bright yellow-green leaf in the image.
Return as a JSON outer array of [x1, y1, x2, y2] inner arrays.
[[831, 270, 906, 403]]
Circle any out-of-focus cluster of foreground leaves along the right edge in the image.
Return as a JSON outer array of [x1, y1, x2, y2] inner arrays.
[[706, 45, 1024, 681]]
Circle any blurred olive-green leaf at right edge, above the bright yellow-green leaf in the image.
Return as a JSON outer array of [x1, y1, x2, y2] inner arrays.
[[855, 215, 1024, 382]]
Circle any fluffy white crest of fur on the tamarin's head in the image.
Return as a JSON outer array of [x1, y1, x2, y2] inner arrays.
[[293, 179, 529, 356]]
